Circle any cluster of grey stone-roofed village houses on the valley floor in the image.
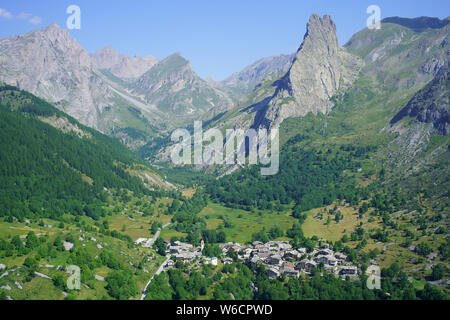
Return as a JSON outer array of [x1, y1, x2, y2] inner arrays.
[[135, 240, 358, 278]]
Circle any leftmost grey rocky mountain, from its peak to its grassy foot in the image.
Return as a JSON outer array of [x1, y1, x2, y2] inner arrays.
[[0, 23, 164, 147]]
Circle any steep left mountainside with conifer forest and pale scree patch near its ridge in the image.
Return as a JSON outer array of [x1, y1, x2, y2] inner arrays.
[[0, 86, 171, 206]]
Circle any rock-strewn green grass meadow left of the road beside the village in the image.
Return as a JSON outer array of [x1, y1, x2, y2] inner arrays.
[[0, 208, 171, 300]]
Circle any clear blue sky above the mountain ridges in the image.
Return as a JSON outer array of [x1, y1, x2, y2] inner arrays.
[[0, 0, 450, 80]]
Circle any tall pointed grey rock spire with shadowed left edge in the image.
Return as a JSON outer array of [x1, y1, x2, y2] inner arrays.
[[255, 14, 362, 127]]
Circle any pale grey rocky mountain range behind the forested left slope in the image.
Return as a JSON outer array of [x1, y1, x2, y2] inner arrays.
[[0, 23, 237, 149]]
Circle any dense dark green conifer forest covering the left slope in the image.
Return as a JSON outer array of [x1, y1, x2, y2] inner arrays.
[[0, 86, 162, 219]]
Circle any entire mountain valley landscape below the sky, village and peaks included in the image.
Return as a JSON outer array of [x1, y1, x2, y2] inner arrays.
[[0, 14, 450, 302]]
